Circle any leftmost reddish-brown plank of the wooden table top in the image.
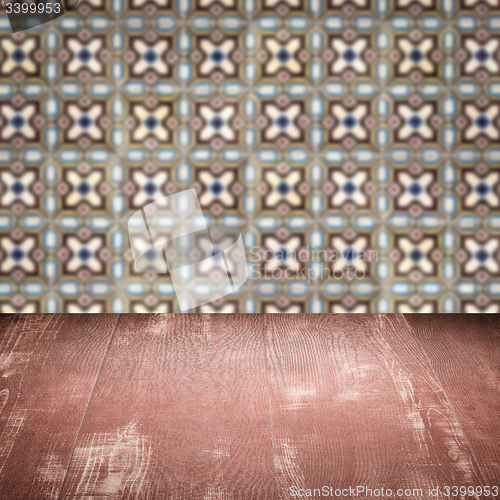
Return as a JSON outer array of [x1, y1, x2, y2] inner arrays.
[[0, 314, 119, 499]]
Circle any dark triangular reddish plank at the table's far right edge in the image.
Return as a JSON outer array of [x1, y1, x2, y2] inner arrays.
[[405, 314, 500, 486]]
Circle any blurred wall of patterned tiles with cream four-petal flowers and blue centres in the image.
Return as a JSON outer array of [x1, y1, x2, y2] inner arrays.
[[0, 0, 500, 312]]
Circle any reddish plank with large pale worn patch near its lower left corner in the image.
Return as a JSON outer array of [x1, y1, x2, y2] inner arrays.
[[62, 314, 274, 499]]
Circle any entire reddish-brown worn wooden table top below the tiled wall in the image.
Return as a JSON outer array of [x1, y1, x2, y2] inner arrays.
[[0, 314, 500, 500]]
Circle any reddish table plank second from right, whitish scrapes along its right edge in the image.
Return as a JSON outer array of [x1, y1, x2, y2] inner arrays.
[[266, 314, 482, 498]]
